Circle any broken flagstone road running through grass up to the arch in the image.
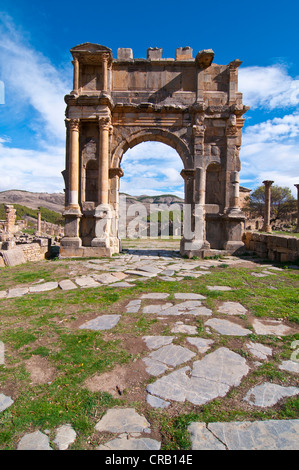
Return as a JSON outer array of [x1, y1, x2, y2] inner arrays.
[[0, 252, 299, 451]]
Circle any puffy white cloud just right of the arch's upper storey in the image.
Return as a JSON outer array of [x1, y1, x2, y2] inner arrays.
[[238, 64, 299, 109]]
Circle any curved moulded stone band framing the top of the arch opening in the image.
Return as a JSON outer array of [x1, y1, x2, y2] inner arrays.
[[111, 128, 193, 169]]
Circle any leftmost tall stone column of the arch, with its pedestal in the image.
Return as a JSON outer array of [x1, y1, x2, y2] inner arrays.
[[61, 119, 82, 251]]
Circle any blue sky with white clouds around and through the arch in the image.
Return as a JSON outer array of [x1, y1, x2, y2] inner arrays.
[[0, 0, 299, 195]]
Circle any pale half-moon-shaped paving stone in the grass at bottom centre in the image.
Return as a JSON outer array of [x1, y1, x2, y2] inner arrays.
[[95, 408, 150, 434]]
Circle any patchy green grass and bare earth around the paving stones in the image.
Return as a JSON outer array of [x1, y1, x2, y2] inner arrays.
[[0, 252, 299, 450]]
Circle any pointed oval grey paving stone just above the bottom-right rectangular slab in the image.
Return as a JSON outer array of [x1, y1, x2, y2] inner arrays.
[[244, 382, 299, 408]]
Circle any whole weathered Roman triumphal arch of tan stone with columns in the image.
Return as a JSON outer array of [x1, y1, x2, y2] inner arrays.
[[60, 43, 249, 257]]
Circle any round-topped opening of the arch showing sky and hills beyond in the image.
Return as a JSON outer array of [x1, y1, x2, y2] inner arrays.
[[119, 141, 185, 250]]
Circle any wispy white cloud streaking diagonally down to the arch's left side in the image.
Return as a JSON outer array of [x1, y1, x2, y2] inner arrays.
[[0, 14, 69, 141]]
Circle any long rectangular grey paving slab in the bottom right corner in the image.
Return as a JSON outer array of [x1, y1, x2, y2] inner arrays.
[[188, 419, 299, 450]]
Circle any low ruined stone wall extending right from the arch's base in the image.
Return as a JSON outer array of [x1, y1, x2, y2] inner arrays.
[[243, 232, 299, 262]]
